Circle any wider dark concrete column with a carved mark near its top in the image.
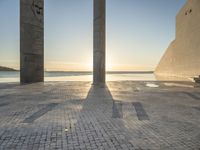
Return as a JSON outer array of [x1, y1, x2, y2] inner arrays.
[[20, 0, 44, 83]]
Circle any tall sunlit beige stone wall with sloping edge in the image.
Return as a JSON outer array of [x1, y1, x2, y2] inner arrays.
[[155, 0, 200, 78]]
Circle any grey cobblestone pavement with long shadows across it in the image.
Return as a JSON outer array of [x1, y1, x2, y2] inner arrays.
[[0, 81, 200, 150]]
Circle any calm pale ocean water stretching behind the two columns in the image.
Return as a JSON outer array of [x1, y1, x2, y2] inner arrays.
[[0, 71, 156, 83]]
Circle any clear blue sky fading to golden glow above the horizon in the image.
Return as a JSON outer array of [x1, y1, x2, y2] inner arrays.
[[0, 0, 186, 71]]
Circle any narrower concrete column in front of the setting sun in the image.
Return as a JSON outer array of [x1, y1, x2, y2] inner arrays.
[[93, 0, 106, 85]]
